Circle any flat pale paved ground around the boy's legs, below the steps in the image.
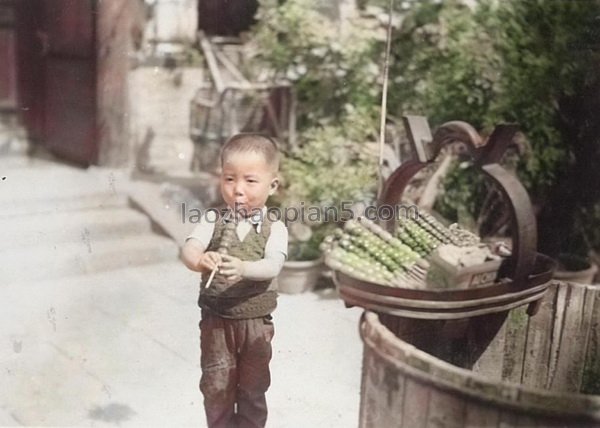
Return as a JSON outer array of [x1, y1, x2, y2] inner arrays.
[[0, 261, 362, 428]]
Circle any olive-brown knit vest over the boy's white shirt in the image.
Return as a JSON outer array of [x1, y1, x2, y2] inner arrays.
[[198, 219, 277, 319]]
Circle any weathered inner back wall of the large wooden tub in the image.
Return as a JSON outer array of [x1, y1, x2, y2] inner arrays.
[[473, 281, 600, 394]]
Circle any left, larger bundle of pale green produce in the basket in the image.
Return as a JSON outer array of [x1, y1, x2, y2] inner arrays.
[[321, 217, 428, 288]]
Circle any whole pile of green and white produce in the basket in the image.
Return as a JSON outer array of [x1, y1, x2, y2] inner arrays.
[[321, 213, 490, 289]]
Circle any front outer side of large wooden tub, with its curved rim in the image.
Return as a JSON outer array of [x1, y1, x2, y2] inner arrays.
[[359, 312, 600, 428]]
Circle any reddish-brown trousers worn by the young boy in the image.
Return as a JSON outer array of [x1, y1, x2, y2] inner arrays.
[[200, 310, 274, 428]]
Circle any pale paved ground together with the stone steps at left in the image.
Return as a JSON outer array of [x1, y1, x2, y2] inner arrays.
[[0, 152, 362, 428]]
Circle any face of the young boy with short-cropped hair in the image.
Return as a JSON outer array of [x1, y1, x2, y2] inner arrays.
[[221, 152, 278, 215]]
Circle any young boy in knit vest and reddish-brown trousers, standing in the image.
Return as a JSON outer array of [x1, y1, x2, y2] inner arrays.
[[182, 134, 288, 428]]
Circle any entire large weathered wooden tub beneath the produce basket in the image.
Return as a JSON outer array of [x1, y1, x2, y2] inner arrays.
[[359, 283, 600, 428]]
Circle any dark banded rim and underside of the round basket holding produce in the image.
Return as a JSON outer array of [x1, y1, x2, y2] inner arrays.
[[334, 254, 555, 368]]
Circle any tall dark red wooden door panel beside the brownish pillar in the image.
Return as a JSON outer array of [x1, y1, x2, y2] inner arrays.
[[42, 0, 98, 165]]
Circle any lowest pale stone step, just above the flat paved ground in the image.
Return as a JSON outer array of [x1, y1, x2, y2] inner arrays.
[[0, 235, 178, 283]]
